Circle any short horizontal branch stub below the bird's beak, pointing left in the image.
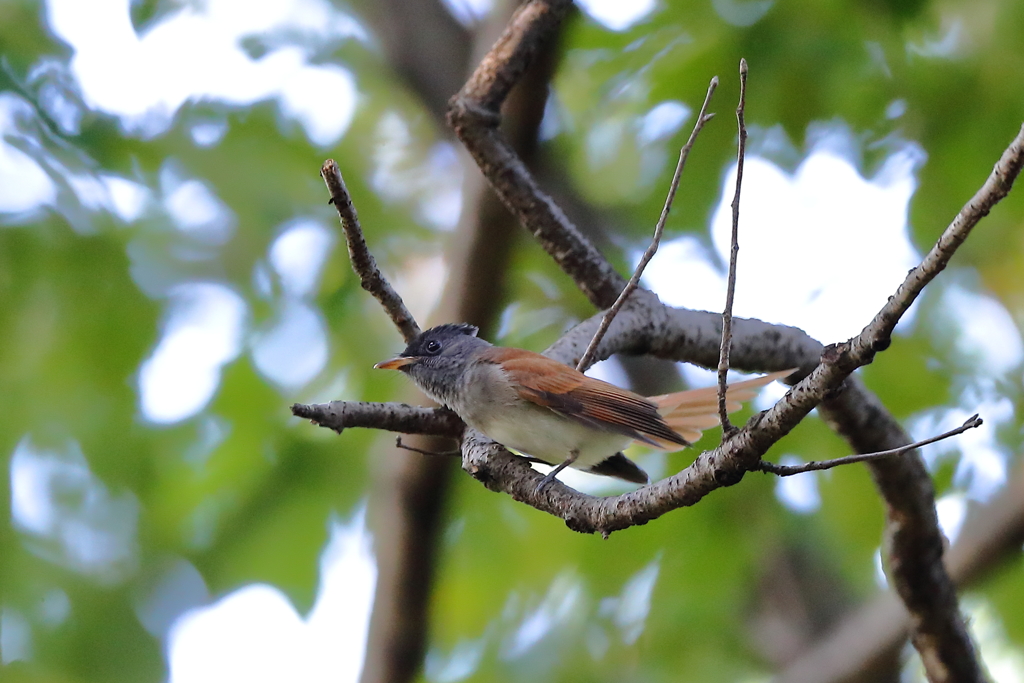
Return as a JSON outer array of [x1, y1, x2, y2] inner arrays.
[[292, 400, 465, 438]]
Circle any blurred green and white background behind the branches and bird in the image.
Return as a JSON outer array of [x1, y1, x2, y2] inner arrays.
[[0, 0, 1024, 683]]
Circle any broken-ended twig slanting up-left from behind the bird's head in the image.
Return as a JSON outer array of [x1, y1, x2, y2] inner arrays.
[[321, 159, 420, 343]]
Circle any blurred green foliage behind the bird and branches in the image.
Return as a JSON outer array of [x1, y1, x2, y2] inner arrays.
[[0, 0, 1024, 682]]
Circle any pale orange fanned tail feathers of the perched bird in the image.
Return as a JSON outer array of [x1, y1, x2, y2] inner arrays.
[[650, 368, 797, 443]]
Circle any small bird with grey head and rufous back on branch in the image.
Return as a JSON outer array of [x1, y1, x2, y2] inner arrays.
[[374, 324, 794, 488]]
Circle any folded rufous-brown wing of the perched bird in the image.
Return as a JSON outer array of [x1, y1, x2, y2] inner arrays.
[[484, 346, 689, 450]]
